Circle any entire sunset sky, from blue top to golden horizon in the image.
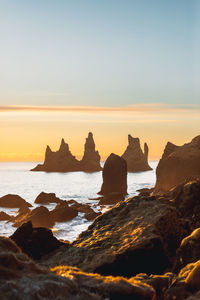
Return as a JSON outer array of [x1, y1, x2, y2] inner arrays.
[[0, 0, 200, 161]]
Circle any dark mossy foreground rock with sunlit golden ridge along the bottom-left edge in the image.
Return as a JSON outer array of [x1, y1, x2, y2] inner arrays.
[[0, 237, 155, 300]]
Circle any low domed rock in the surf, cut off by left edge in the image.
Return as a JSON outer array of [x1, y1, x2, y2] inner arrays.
[[0, 194, 32, 208]]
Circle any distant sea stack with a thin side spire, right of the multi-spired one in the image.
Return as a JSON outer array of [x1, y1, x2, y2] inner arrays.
[[121, 134, 152, 172]]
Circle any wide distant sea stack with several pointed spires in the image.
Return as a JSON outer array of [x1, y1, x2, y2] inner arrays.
[[31, 132, 102, 172]]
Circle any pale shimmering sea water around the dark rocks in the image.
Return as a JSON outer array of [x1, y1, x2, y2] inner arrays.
[[0, 161, 158, 242]]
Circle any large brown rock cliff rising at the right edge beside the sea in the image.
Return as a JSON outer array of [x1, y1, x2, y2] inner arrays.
[[154, 136, 200, 194]]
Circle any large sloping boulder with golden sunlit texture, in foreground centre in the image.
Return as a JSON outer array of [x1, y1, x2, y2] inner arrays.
[[43, 197, 183, 277]]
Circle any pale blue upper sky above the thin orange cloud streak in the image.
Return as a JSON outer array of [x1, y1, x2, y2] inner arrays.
[[0, 0, 200, 106]]
